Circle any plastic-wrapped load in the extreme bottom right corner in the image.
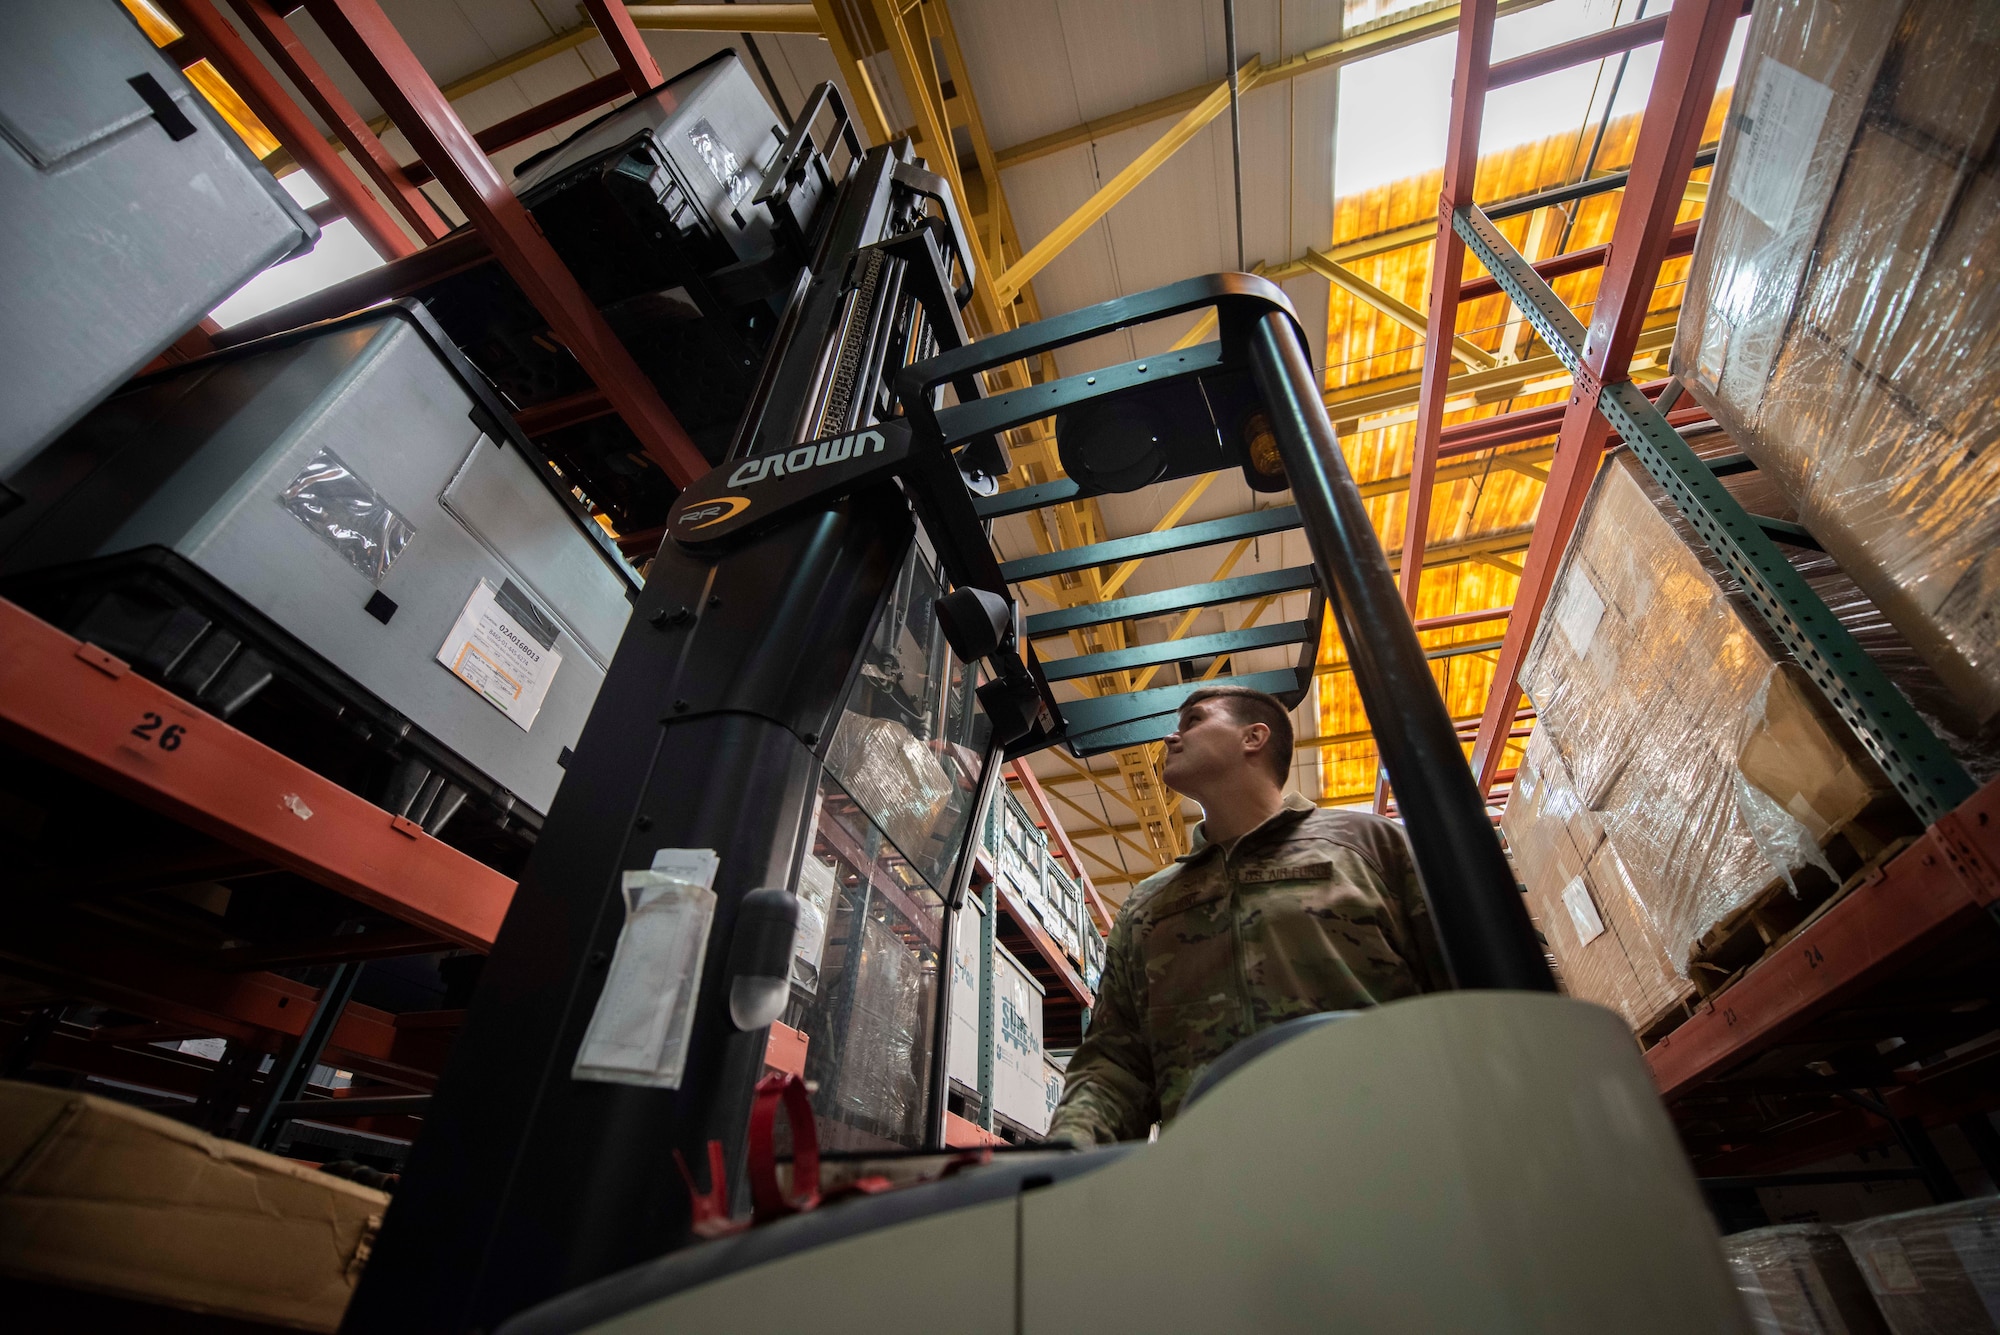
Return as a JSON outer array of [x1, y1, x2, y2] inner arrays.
[[1840, 1195, 2000, 1335]]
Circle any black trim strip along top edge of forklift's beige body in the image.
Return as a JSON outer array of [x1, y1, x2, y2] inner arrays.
[[494, 1143, 1138, 1335]]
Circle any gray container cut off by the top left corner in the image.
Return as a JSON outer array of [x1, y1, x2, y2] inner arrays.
[[0, 0, 320, 478]]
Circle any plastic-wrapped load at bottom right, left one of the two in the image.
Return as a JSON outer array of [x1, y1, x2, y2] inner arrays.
[[1722, 1223, 1888, 1335]]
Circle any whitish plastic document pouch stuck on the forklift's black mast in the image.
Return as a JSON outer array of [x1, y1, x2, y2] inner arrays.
[[570, 849, 716, 1089]]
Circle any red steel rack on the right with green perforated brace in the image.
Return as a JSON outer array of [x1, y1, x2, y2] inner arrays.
[[1404, 0, 2000, 1199]]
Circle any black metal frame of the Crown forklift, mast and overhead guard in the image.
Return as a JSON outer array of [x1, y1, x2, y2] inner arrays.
[[344, 158, 1554, 1333]]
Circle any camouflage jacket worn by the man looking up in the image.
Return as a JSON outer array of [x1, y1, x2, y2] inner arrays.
[[1048, 795, 1446, 1145]]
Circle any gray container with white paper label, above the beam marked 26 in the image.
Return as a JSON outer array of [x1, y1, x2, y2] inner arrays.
[[0, 304, 636, 813]]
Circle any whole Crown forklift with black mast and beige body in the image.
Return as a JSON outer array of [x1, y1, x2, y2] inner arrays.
[[342, 57, 1748, 1335]]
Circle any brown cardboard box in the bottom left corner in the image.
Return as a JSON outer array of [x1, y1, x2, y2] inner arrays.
[[0, 1081, 388, 1331]]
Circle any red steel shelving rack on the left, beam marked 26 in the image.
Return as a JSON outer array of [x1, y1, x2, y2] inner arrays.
[[0, 0, 780, 1143]]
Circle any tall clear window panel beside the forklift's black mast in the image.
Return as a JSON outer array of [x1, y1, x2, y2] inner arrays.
[[784, 552, 992, 1151]]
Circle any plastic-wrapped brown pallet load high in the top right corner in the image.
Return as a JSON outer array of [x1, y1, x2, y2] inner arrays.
[[1672, 0, 2000, 733]]
